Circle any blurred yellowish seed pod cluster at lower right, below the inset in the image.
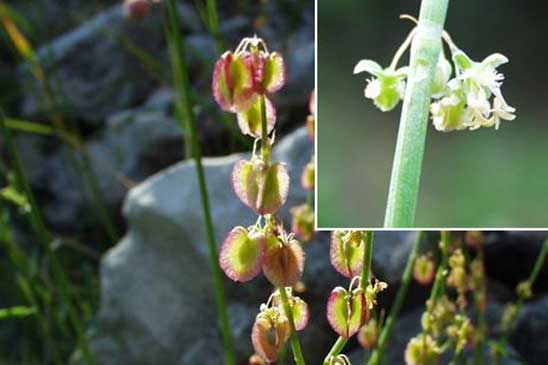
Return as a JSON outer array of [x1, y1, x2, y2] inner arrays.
[[405, 232, 486, 365]]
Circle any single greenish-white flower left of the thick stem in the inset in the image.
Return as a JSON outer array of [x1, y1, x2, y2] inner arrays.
[[354, 60, 409, 112]]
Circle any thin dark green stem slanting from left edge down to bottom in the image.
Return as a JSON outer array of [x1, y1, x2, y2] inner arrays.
[[0, 109, 95, 364]]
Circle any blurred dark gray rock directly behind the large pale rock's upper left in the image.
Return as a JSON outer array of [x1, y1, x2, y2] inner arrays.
[[39, 90, 183, 230]]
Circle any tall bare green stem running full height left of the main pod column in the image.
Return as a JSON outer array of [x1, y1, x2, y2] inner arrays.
[[161, 0, 236, 365]]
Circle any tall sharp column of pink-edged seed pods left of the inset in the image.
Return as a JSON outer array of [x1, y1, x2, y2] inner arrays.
[[212, 36, 308, 363]]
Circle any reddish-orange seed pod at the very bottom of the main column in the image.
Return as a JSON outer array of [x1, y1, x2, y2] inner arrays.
[[251, 308, 290, 363]]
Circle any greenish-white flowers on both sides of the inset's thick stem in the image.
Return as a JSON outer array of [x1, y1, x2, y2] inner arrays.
[[354, 15, 516, 132]]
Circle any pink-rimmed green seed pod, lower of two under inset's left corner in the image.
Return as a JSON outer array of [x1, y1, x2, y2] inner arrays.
[[327, 287, 369, 338]]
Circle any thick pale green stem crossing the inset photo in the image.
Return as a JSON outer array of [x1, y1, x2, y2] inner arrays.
[[384, 0, 449, 228]]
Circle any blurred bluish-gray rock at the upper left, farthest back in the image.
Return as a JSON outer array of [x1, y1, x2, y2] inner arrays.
[[20, 4, 201, 125]]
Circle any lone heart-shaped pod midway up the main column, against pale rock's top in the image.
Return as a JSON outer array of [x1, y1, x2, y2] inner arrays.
[[232, 158, 289, 215]]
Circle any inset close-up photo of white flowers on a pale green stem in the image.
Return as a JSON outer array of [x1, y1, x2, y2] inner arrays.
[[316, 0, 548, 230]]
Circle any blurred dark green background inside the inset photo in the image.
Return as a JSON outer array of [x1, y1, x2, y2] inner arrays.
[[317, 0, 548, 228]]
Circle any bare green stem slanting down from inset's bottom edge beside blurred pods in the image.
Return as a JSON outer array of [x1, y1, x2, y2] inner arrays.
[[368, 232, 424, 365]]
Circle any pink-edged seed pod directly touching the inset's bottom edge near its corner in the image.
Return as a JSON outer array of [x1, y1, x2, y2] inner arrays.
[[329, 232, 364, 279]]
